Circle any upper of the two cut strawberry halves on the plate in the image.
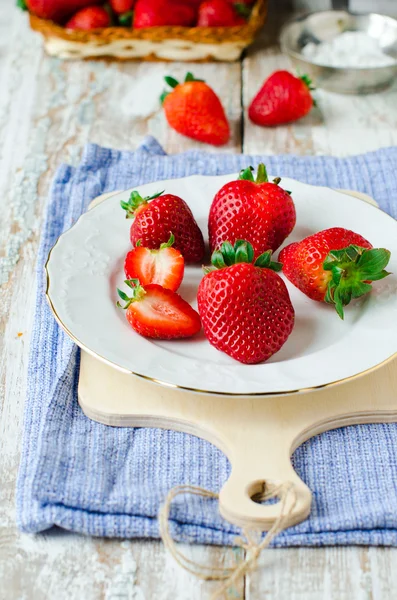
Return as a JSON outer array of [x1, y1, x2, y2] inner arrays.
[[124, 234, 185, 292]]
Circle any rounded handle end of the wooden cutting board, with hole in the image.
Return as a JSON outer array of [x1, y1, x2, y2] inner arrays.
[[219, 442, 312, 531]]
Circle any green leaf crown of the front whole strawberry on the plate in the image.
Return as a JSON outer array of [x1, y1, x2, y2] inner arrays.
[[209, 240, 282, 272]]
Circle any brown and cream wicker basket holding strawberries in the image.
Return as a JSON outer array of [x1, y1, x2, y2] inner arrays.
[[30, 0, 267, 62]]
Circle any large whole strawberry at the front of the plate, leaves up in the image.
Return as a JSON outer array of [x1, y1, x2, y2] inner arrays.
[[197, 240, 294, 364]]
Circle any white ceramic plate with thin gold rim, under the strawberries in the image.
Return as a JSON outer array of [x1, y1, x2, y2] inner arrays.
[[47, 175, 397, 395]]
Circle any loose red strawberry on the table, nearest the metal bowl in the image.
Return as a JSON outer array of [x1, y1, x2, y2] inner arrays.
[[248, 71, 314, 127]]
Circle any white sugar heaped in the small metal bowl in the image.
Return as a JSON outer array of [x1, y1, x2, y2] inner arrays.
[[302, 31, 396, 68]]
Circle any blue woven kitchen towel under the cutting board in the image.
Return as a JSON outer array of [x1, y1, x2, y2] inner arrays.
[[17, 138, 397, 546]]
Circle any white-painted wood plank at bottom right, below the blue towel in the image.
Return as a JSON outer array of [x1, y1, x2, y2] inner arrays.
[[246, 546, 397, 600]]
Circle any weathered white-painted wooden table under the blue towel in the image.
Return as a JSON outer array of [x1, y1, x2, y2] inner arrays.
[[0, 0, 397, 600]]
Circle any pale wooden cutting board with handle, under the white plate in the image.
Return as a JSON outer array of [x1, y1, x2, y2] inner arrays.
[[78, 190, 397, 530]]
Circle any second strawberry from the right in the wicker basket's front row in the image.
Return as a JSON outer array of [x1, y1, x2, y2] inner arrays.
[[133, 0, 197, 29]]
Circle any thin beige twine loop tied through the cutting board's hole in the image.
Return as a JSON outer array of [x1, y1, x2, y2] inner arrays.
[[159, 482, 297, 600]]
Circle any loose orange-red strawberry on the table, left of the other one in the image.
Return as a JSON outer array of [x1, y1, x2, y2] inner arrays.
[[161, 73, 230, 146]]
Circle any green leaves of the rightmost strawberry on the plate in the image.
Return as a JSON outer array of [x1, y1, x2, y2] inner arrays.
[[323, 244, 390, 319]]
